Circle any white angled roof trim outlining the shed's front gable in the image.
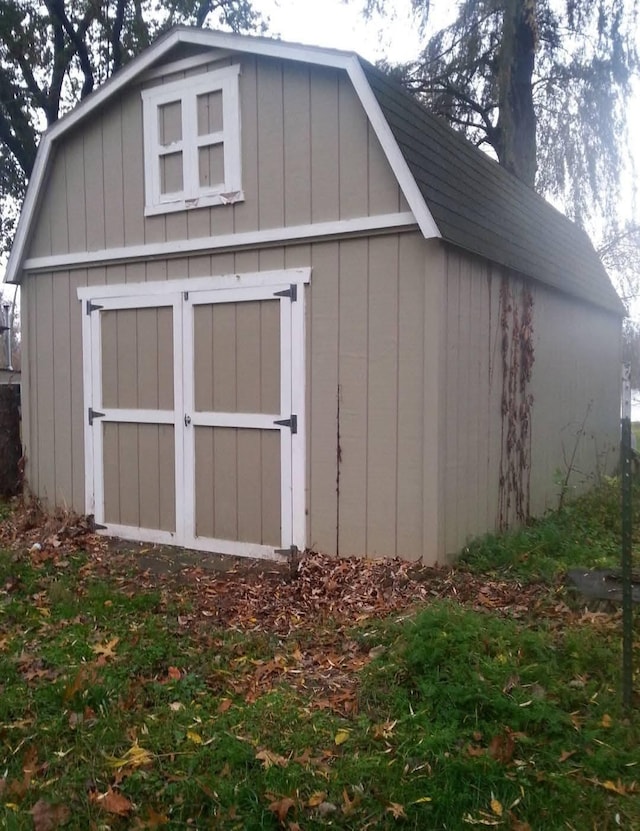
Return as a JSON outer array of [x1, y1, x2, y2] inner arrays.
[[5, 27, 441, 283]]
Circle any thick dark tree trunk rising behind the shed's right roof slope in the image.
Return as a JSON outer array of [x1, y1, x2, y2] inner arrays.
[[496, 0, 537, 187]]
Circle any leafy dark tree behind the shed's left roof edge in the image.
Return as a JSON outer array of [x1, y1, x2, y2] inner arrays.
[[0, 0, 261, 251]]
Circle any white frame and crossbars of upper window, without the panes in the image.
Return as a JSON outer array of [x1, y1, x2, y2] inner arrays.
[[142, 64, 244, 216]]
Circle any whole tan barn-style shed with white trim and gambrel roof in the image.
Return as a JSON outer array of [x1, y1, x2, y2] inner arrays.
[[8, 28, 624, 563]]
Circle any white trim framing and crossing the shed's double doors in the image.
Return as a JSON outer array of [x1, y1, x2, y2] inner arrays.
[[77, 268, 311, 559]]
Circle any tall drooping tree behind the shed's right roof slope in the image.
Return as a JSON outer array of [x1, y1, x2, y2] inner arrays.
[[368, 0, 638, 229]]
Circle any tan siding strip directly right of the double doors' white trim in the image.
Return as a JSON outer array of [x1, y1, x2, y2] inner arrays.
[[308, 243, 340, 554]]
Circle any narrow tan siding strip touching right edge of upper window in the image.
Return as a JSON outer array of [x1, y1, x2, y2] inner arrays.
[[234, 55, 258, 233]]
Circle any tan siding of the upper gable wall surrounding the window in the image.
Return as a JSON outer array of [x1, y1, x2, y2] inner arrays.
[[27, 57, 408, 257]]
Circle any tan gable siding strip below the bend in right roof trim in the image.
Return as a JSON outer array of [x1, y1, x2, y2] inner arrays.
[[338, 75, 368, 219]]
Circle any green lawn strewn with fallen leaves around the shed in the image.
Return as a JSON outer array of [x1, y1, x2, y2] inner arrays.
[[0, 485, 640, 831]]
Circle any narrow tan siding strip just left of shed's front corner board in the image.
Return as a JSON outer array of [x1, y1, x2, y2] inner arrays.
[[396, 235, 425, 558]]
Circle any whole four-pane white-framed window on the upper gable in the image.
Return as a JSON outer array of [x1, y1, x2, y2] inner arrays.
[[142, 65, 244, 216]]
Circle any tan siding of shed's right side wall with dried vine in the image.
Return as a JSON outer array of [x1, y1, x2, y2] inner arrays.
[[443, 249, 620, 555]]
